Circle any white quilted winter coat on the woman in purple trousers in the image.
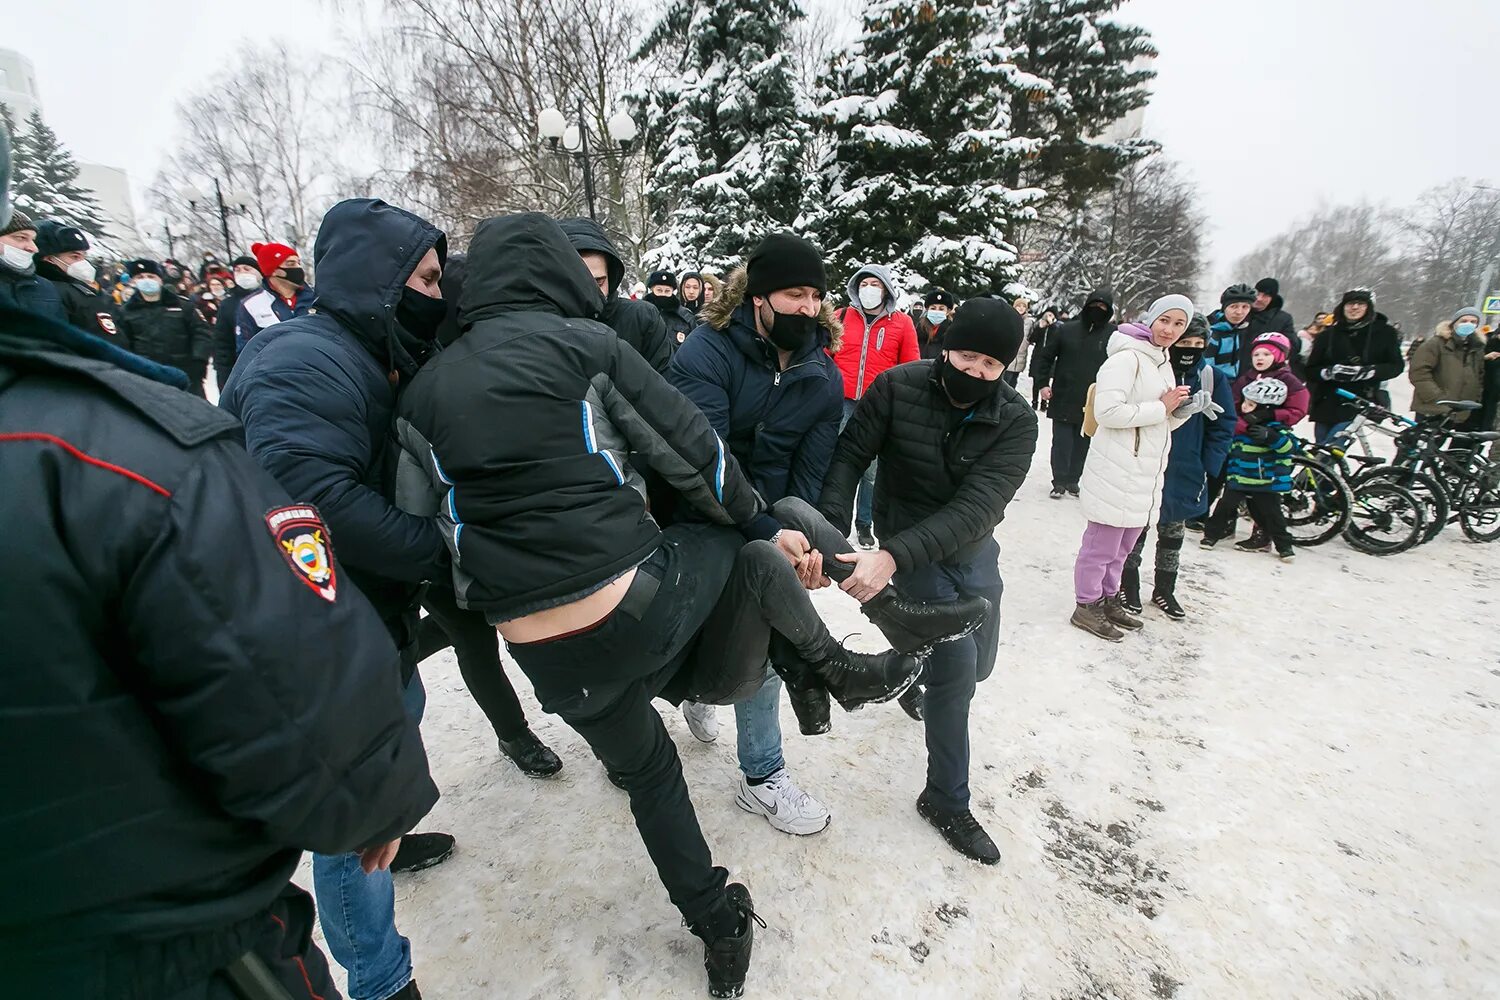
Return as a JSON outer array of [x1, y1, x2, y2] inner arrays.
[[1079, 330, 1185, 528]]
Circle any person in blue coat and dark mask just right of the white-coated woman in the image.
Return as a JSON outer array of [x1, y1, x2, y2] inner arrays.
[[1121, 316, 1235, 619]]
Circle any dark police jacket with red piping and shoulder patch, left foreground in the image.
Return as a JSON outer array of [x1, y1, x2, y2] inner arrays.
[[0, 302, 437, 977]]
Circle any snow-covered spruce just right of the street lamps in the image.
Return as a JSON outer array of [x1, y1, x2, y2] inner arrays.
[[638, 0, 810, 271]]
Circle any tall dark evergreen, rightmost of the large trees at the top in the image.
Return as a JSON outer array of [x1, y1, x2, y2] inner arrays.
[[1004, 0, 1158, 208]]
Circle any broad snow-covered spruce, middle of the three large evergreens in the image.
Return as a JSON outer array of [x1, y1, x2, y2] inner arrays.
[[807, 0, 1044, 295]]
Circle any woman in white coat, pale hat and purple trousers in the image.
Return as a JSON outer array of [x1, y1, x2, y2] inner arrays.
[[1073, 295, 1193, 642]]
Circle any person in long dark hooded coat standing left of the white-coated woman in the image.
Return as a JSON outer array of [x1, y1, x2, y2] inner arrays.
[[1035, 288, 1115, 499]]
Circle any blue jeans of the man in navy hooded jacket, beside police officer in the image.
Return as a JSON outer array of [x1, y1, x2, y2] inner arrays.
[[312, 673, 428, 1000]]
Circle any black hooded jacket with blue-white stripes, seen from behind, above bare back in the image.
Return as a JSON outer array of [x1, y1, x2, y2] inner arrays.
[[398, 213, 765, 641]]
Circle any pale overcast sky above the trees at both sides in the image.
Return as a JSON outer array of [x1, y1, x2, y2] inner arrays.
[[0, 0, 1500, 283]]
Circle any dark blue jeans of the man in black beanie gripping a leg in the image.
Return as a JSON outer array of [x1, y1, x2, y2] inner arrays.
[[896, 538, 1004, 813]]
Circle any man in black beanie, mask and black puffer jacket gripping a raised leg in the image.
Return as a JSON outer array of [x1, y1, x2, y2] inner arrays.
[[810, 298, 1037, 865]]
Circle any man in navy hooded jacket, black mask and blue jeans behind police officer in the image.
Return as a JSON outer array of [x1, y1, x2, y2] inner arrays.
[[219, 198, 453, 1000]]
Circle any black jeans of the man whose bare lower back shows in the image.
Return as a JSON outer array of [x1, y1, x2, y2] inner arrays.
[[510, 525, 833, 927]]
